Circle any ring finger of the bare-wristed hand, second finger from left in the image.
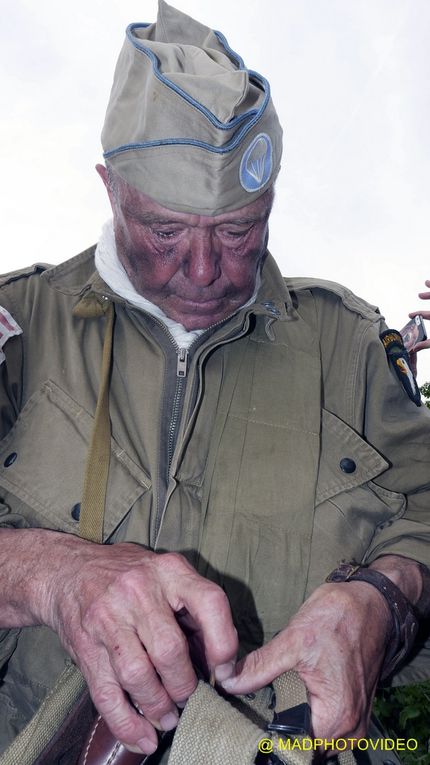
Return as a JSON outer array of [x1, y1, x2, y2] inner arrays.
[[109, 631, 178, 730]]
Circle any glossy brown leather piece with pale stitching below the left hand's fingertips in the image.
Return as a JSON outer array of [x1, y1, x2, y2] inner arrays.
[[77, 715, 150, 765]]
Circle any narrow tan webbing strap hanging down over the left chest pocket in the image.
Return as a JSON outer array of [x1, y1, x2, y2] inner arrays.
[[79, 303, 115, 542]]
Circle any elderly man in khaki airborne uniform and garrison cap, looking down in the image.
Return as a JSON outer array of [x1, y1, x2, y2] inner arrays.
[[0, 0, 430, 753]]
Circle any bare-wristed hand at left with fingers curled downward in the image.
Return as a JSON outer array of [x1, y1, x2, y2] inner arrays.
[[1, 530, 238, 754]]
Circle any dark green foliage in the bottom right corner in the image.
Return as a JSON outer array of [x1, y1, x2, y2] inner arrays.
[[373, 680, 430, 765]]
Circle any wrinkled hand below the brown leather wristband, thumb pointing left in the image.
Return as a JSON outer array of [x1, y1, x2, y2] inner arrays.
[[222, 582, 391, 739]]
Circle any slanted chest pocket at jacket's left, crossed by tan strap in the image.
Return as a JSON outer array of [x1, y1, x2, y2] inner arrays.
[[0, 381, 151, 538]]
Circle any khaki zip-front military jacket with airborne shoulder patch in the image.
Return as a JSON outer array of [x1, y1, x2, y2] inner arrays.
[[0, 249, 430, 741]]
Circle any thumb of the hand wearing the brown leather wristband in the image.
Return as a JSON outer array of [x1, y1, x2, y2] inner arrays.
[[221, 632, 296, 694]]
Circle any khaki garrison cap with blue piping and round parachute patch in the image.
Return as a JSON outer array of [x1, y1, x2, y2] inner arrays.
[[102, 0, 282, 215]]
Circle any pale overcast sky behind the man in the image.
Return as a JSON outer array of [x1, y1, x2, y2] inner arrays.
[[0, 0, 430, 382]]
